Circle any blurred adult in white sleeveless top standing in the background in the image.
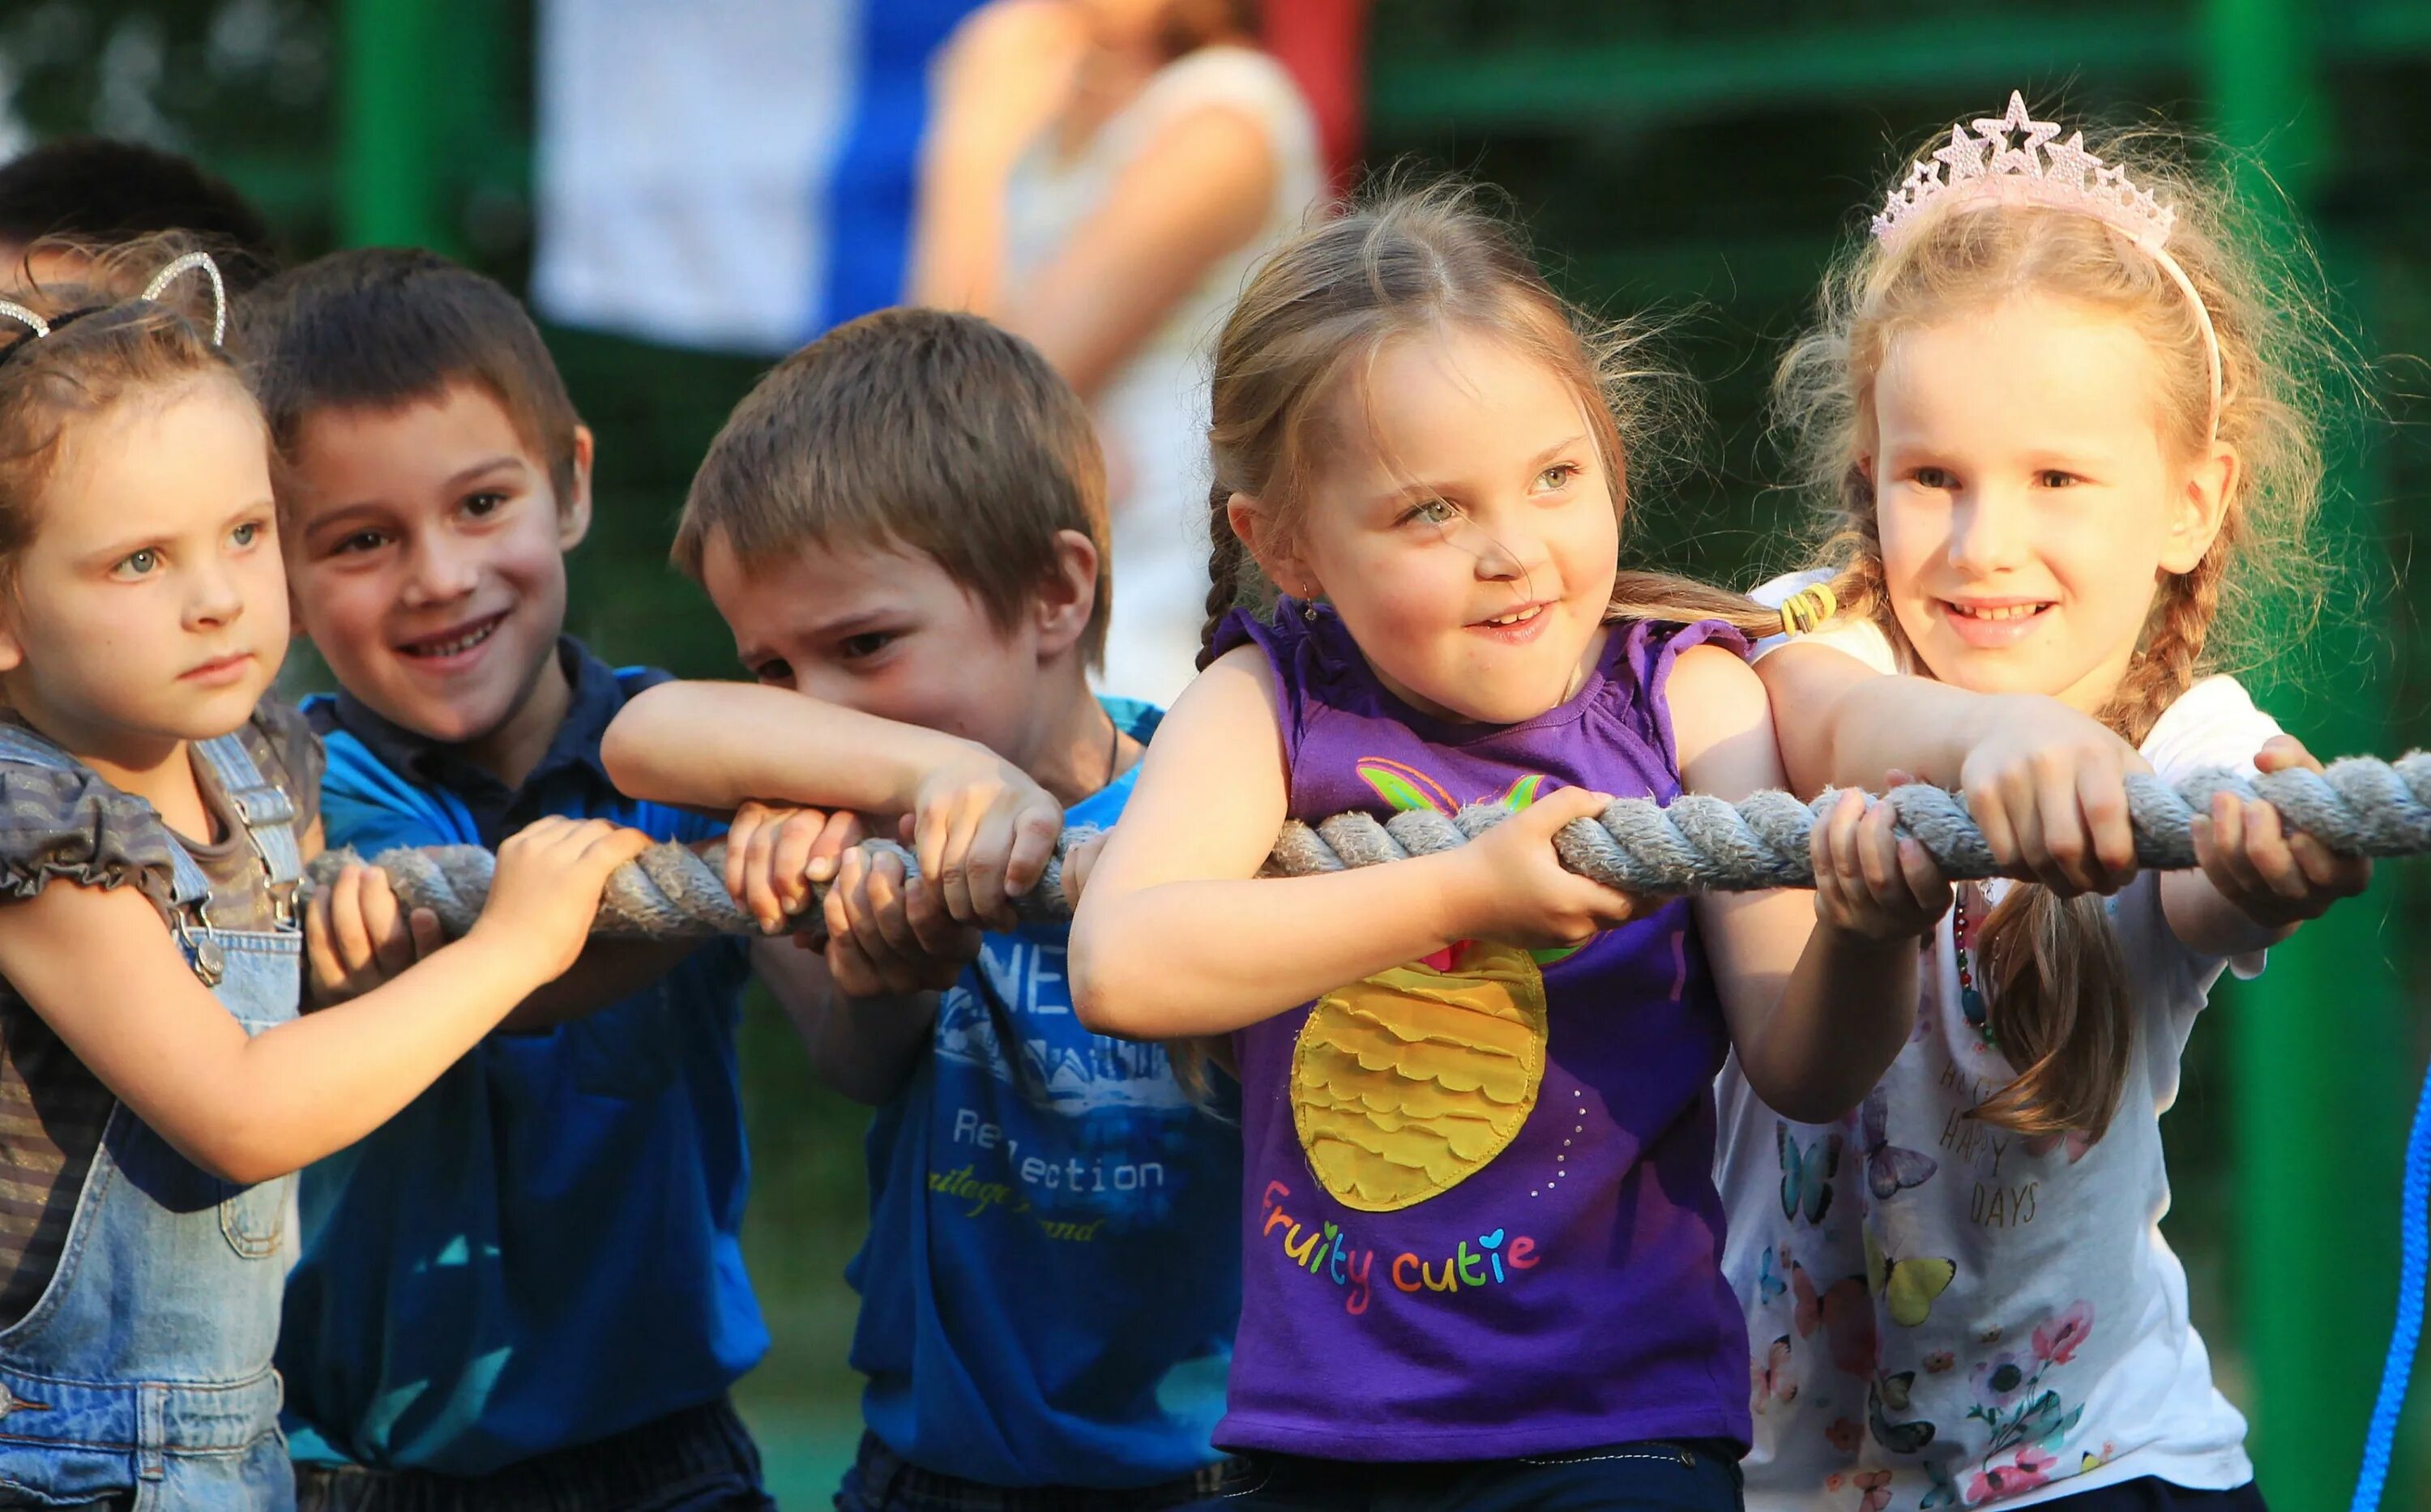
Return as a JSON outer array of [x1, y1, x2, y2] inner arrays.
[[907, 0, 1325, 703]]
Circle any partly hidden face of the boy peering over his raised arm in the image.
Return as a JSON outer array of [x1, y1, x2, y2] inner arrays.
[[700, 530, 1040, 763]]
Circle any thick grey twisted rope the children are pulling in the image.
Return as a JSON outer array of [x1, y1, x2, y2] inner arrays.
[[311, 751, 2431, 938]]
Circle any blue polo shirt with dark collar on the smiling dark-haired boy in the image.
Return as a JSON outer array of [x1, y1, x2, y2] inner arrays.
[[277, 639, 768, 1476]]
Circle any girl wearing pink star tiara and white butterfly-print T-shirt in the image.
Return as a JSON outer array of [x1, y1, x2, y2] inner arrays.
[[1719, 95, 2370, 1512]]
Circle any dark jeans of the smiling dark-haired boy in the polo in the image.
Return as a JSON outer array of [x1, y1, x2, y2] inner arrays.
[[297, 1398, 775, 1512]]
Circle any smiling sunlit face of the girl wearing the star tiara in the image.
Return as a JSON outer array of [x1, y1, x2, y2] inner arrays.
[[1869, 297, 2217, 710]]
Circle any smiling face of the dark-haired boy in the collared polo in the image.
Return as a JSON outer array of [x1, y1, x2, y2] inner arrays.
[[284, 384, 588, 744]]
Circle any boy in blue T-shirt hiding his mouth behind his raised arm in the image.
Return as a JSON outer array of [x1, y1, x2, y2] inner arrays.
[[605, 309, 1240, 1512]]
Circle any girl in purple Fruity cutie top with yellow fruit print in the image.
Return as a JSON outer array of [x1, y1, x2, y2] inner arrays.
[[1070, 192, 1930, 1510]]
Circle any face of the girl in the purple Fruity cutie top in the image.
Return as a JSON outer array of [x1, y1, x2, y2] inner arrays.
[[1281, 328, 1619, 724]]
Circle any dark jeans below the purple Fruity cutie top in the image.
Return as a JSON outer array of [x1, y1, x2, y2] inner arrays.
[[1211, 1439, 1741, 1512]]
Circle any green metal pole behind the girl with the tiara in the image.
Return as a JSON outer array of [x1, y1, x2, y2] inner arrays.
[[2205, 0, 2412, 1512]]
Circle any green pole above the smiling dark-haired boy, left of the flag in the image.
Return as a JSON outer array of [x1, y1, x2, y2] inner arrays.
[[338, 0, 457, 253]]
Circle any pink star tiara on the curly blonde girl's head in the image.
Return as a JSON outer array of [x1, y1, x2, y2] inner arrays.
[[1872, 90, 2222, 438]]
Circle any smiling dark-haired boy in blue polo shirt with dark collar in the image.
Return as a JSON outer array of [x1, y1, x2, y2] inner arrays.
[[246, 250, 768, 1512]]
